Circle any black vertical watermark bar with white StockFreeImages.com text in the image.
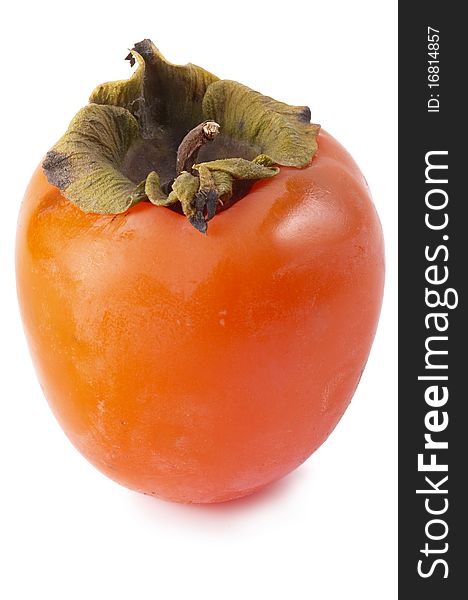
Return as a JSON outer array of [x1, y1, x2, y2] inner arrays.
[[399, 0, 468, 600]]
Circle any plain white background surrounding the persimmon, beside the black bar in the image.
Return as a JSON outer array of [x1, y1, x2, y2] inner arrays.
[[0, 0, 397, 600]]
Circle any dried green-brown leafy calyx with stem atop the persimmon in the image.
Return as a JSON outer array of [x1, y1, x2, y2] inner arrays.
[[43, 40, 320, 233]]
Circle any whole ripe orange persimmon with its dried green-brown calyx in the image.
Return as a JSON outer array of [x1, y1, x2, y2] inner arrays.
[[17, 40, 384, 502]]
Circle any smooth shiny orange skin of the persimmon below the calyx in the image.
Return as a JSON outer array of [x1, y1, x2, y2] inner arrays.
[[16, 131, 384, 503]]
